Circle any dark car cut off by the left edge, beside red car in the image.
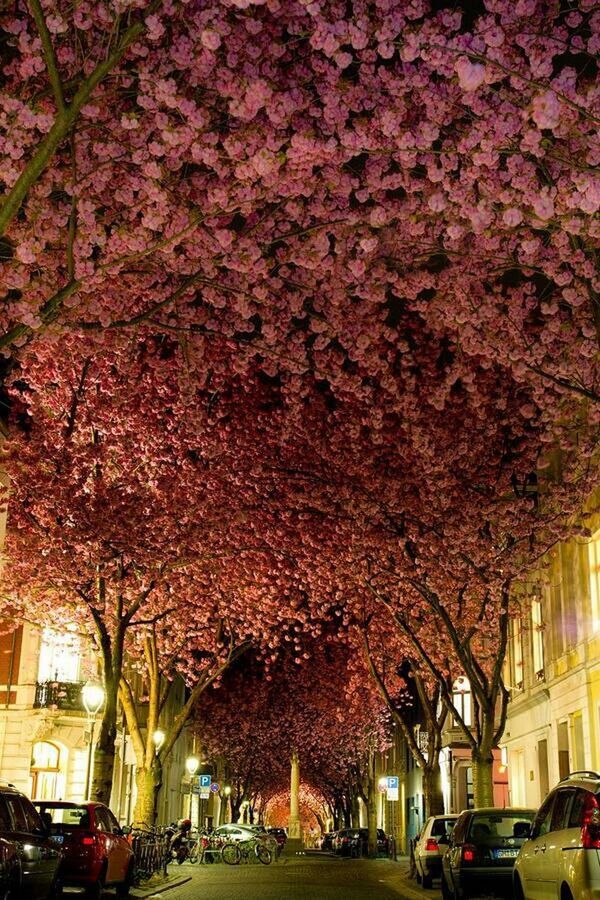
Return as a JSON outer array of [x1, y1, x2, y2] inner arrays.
[[0, 784, 61, 900]]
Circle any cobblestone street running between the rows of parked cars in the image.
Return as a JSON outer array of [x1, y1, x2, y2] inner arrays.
[[135, 857, 440, 900]]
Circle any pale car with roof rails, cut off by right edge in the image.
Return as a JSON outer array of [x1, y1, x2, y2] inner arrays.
[[513, 772, 600, 900]]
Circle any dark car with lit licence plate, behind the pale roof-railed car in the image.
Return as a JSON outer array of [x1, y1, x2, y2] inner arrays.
[[438, 807, 535, 900]]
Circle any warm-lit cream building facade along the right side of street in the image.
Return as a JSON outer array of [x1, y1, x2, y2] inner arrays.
[[503, 520, 600, 807]]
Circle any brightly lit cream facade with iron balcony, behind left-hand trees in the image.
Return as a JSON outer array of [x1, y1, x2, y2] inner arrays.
[[0, 622, 192, 824]]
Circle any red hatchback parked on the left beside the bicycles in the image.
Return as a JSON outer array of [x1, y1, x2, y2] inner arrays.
[[34, 800, 134, 900]]
